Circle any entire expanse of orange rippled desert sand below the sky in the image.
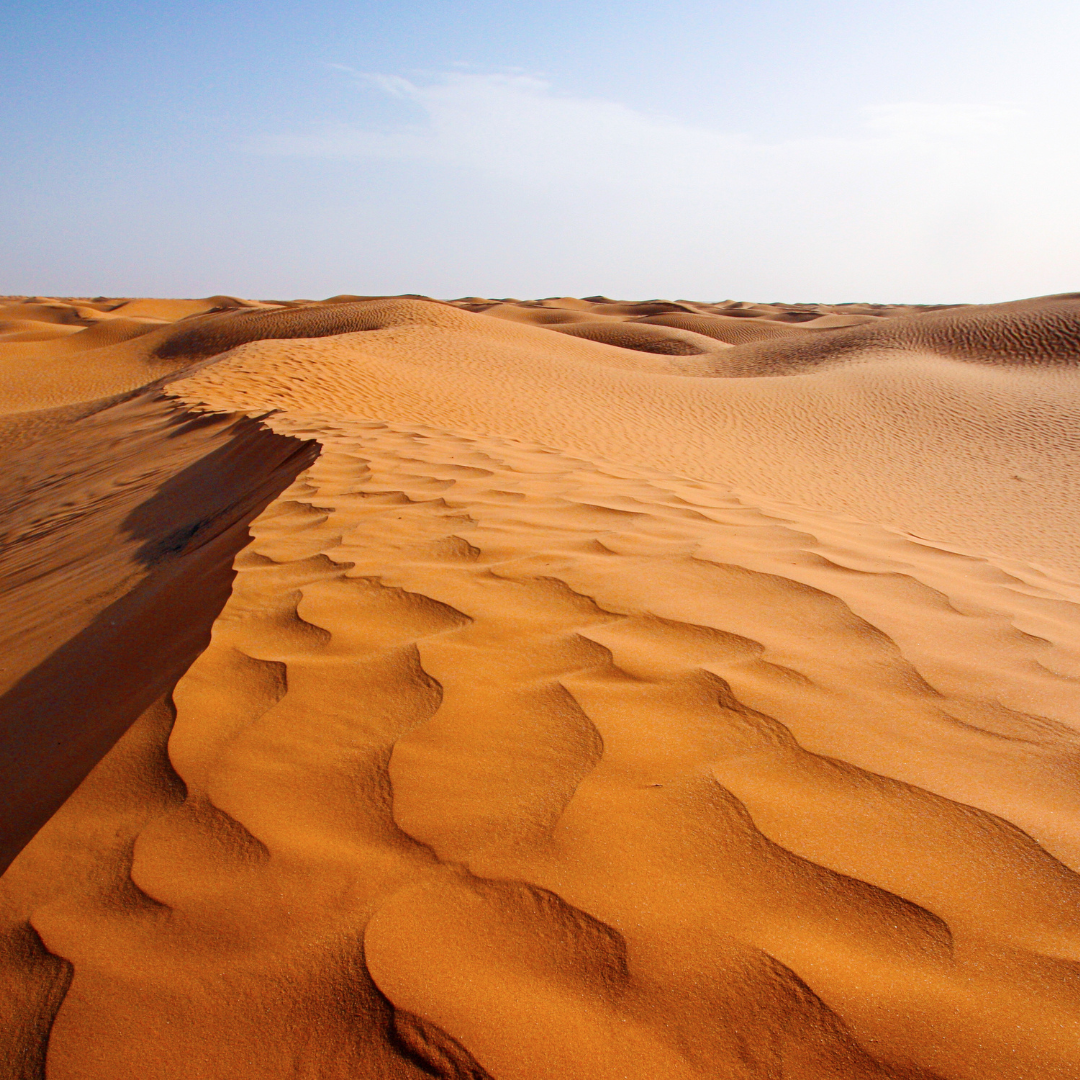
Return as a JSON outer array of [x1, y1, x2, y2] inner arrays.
[[0, 294, 1080, 1080]]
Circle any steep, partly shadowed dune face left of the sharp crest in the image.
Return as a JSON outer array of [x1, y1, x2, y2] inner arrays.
[[0, 392, 312, 868]]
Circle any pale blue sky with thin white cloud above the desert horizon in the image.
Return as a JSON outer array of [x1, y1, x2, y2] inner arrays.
[[0, 0, 1080, 303]]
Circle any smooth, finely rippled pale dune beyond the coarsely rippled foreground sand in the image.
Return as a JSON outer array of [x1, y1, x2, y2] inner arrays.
[[166, 291, 1080, 570]]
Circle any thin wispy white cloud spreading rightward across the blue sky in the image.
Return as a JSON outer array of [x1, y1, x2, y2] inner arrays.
[[247, 69, 1080, 299]]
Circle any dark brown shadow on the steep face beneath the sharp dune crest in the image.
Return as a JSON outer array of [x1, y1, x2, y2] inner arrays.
[[0, 418, 318, 872]]
